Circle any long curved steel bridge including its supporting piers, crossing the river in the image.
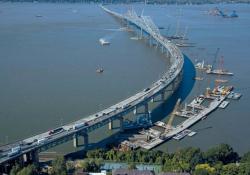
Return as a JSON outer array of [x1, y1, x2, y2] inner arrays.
[[0, 6, 184, 173]]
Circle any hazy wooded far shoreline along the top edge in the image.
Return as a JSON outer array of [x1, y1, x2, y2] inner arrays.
[[0, 0, 250, 4]]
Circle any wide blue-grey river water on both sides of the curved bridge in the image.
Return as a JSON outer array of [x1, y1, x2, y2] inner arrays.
[[0, 3, 250, 153]]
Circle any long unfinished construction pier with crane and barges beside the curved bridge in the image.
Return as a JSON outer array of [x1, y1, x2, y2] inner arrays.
[[121, 86, 241, 150]]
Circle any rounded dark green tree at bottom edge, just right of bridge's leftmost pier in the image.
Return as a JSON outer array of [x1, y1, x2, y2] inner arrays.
[[52, 156, 67, 175]]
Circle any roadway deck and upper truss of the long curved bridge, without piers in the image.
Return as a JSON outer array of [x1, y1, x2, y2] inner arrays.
[[0, 6, 184, 164]]
